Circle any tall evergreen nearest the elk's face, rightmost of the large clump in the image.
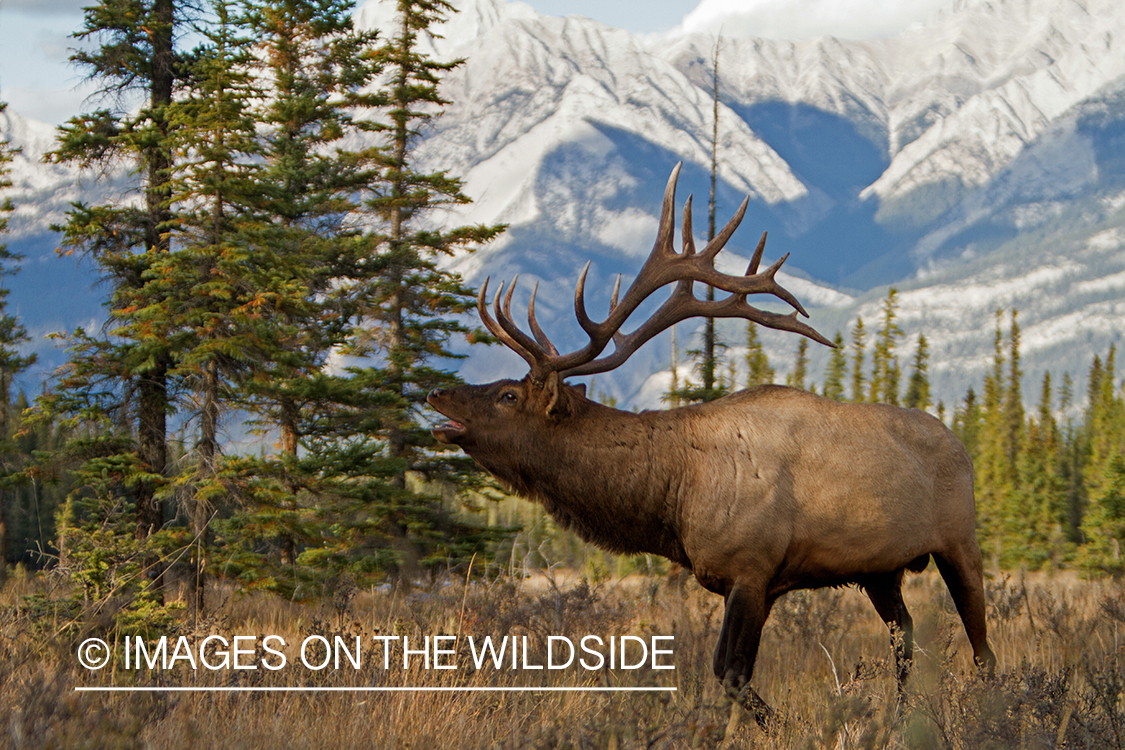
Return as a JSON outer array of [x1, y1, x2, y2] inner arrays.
[[339, 0, 503, 582]]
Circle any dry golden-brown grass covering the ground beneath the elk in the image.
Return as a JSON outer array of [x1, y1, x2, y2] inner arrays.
[[0, 573, 1125, 749]]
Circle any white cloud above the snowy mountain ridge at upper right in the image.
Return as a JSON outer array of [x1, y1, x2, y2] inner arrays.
[[674, 0, 951, 39]]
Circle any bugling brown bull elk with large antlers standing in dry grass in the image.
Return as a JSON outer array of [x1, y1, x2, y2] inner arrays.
[[429, 165, 996, 722]]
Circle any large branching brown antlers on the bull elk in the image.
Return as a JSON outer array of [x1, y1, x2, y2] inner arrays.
[[477, 164, 833, 382]]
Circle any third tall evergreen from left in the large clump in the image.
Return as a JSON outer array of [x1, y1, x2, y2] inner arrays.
[[207, 0, 387, 597]]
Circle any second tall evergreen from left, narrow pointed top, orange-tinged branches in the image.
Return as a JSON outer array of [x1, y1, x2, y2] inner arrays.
[[144, 0, 268, 613]]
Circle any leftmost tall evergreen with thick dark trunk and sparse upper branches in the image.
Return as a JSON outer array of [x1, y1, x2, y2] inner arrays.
[[38, 0, 186, 598]]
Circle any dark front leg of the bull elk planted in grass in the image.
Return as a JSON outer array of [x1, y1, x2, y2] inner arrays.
[[714, 584, 773, 726]]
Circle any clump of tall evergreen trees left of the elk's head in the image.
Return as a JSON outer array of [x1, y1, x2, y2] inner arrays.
[[19, 0, 512, 622]]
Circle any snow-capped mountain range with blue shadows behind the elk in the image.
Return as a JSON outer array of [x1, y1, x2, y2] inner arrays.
[[5, 0, 1125, 406]]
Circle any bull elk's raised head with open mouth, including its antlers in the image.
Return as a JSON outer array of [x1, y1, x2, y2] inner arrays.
[[429, 159, 833, 440]]
